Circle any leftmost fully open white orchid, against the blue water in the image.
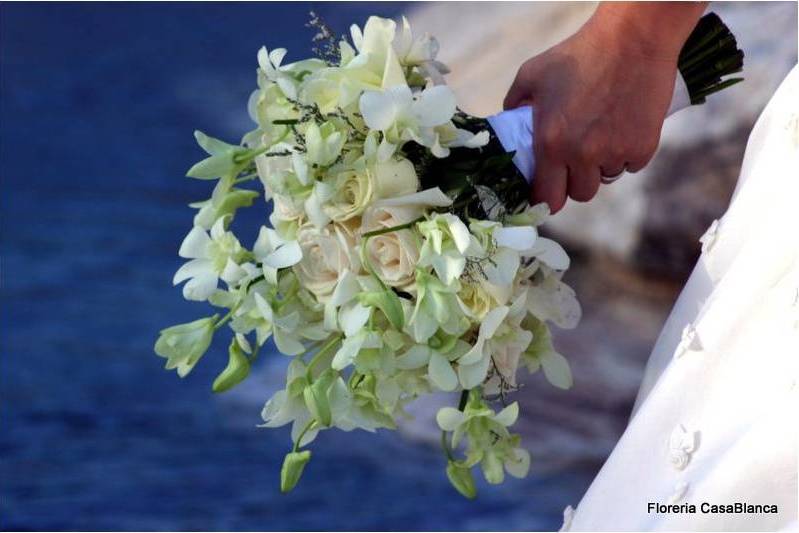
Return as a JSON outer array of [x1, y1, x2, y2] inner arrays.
[[172, 218, 248, 301]]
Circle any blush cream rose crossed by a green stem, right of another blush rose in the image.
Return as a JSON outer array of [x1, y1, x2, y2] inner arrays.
[[361, 206, 421, 287]]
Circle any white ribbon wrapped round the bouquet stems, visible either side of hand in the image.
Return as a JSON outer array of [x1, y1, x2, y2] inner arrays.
[[487, 74, 691, 183]]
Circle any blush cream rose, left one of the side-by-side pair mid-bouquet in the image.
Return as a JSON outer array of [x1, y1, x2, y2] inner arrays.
[[294, 224, 360, 302]]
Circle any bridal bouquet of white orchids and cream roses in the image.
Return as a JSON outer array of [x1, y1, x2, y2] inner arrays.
[[155, 12, 744, 497]]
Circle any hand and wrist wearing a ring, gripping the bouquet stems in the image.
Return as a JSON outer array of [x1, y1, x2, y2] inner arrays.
[[505, 3, 704, 213]]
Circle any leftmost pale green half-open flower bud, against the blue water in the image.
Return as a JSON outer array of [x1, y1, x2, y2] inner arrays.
[[155, 315, 219, 377]]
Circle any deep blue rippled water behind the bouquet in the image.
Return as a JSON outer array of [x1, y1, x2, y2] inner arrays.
[[0, 3, 590, 530]]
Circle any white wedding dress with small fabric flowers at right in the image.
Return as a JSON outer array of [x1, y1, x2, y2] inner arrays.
[[563, 67, 799, 531]]
